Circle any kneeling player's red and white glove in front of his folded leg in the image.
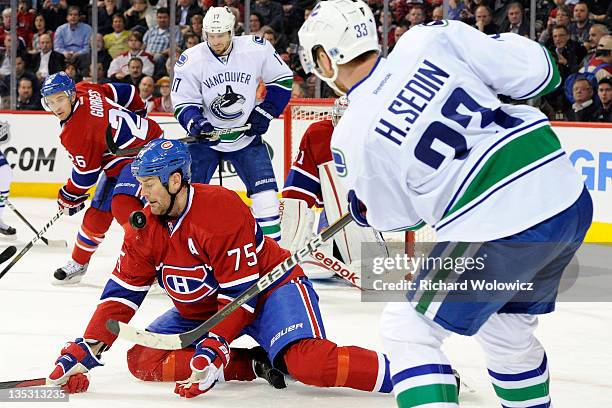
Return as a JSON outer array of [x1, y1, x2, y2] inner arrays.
[[174, 333, 230, 398]]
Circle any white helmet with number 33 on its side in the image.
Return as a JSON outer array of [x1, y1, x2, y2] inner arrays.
[[298, 0, 380, 95]]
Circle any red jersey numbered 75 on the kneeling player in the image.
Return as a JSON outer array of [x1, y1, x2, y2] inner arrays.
[[85, 184, 303, 345]]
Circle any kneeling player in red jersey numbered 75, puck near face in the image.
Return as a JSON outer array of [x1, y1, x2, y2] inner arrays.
[[49, 139, 392, 398]]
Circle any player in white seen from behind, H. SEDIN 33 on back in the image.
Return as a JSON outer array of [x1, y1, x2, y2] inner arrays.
[[299, 0, 592, 408]]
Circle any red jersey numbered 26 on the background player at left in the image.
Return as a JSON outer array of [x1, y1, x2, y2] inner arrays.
[[60, 82, 163, 194]]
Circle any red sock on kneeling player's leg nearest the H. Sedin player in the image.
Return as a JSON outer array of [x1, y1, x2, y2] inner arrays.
[[284, 339, 392, 393]]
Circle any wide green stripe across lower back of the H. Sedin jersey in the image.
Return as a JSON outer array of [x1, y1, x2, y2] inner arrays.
[[444, 126, 561, 218]]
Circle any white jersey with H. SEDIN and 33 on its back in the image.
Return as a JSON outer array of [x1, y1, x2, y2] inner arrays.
[[332, 21, 583, 241]]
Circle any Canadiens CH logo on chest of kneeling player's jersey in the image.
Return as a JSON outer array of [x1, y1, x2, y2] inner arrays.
[[162, 265, 218, 303]]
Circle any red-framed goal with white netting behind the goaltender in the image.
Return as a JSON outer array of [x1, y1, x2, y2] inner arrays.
[[283, 99, 436, 255]]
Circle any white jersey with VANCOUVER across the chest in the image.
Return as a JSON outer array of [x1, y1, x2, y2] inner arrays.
[[172, 35, 293, 152]]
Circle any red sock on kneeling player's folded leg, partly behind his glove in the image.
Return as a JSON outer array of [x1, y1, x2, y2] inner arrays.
[[127, 346, 255, 381]]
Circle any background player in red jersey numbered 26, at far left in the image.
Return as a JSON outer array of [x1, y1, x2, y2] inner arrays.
[[41, 72, 163, 285]]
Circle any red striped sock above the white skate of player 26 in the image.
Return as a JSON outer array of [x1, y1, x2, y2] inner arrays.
[[72, 207, 113, 265]]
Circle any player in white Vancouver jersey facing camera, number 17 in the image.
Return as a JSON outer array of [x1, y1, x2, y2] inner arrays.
[[171, 7, 293, 241]]
